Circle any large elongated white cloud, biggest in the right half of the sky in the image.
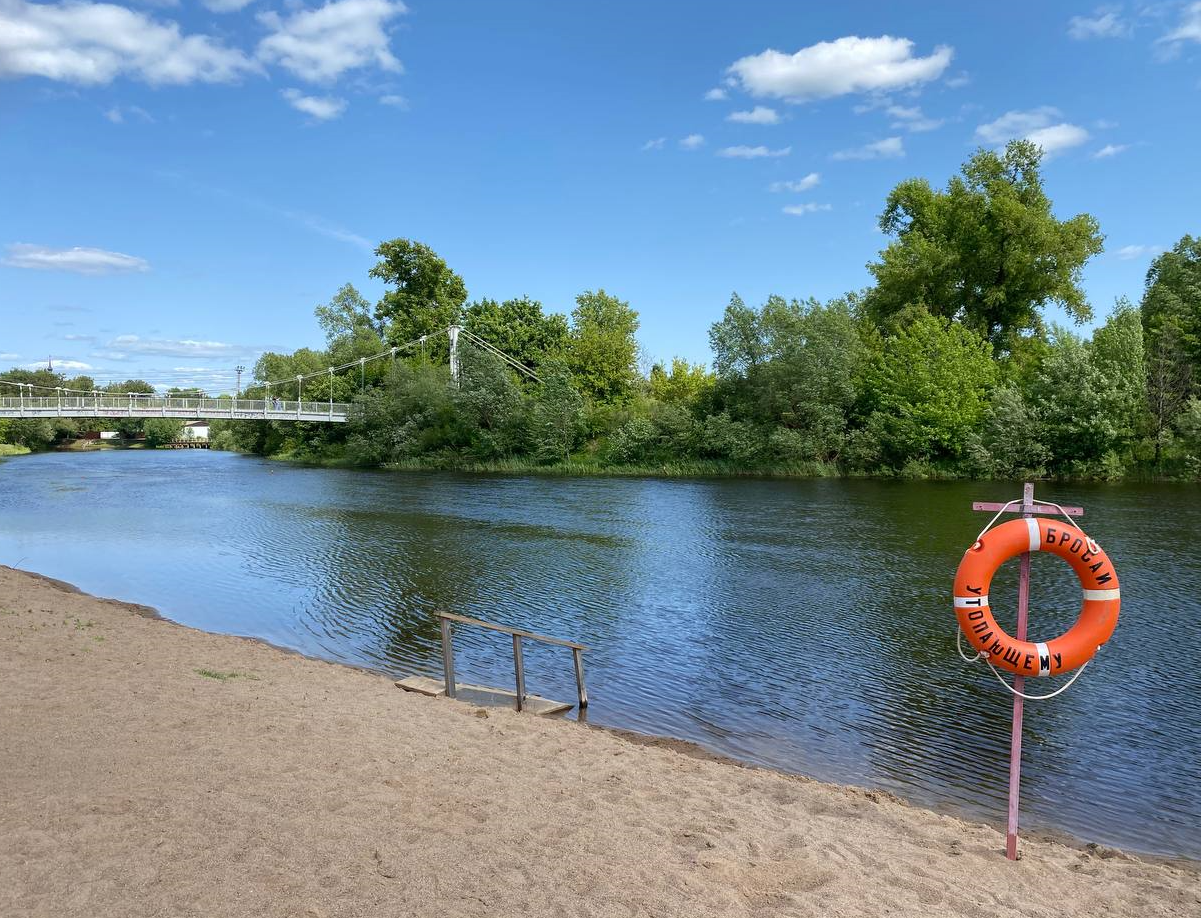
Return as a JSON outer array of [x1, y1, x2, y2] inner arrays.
[[728, 35, 955, 102]]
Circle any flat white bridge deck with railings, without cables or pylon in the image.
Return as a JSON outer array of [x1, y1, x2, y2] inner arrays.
[[0, 393, 351, 424]]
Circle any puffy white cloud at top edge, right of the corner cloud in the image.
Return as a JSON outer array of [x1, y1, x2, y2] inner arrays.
[[258, 0, 407, 83]]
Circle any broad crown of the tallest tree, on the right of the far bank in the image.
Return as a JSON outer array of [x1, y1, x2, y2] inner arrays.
[[866, 141, 1104, 353]]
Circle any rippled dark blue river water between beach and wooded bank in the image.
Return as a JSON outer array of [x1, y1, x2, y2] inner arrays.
[[0, 451, 1201, 858]]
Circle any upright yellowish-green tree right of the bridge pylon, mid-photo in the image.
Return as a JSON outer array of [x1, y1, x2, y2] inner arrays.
[[568, 290, 638, 404]]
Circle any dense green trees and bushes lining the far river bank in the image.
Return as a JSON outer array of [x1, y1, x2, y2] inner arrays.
[[7, 142, 1201, 478]]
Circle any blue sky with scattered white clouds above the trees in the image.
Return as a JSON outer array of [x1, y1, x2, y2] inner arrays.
[[0, 0, 1201, 391]]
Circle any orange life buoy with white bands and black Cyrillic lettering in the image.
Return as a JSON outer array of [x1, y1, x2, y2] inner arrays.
[[955, 518, 1122, 676]]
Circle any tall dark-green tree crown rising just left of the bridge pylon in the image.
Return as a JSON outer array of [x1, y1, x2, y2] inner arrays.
[[371, 239, 467, 345]]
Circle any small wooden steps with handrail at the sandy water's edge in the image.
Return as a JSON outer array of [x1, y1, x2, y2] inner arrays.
[[396, 612, 588, 714]]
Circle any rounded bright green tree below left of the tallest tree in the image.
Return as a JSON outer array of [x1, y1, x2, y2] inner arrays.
[[865, 309, 997, 467]]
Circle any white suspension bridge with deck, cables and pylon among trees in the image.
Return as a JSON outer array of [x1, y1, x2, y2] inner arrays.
[[0, 326, 538, 424]]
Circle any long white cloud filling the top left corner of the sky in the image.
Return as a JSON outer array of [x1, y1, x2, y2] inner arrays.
[[0, 0, 258, 85]]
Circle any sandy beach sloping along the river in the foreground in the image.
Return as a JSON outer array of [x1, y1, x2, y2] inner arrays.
[[0, 567, 1201, 918]]
